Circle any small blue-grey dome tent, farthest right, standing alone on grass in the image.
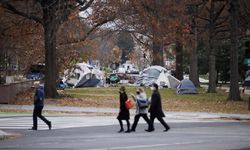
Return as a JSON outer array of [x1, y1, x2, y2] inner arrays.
[[176, 79, 197, 94]]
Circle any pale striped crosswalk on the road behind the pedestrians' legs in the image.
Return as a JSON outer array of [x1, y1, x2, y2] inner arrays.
[[0, 116, 217, 130]]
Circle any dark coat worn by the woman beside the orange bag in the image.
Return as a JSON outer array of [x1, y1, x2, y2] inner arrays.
[[117, 93, 130, 120]]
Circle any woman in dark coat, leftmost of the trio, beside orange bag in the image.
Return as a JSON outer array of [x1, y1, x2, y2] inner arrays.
[[117, 86, 130, 133]]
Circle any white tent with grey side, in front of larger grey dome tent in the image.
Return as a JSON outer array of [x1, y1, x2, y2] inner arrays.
[[156, 71, 180, 89]]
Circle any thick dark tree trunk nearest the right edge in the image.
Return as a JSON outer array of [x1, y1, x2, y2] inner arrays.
[[228, 0, 241, 101]]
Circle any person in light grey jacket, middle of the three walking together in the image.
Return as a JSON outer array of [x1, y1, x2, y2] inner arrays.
[[131, 87, 152, 132]]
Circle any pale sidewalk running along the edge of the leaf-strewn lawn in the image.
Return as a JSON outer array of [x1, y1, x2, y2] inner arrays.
[[0, 104, 250, 120]]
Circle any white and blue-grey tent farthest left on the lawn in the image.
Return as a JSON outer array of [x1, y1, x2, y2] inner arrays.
[[63, 63, 103, 87]]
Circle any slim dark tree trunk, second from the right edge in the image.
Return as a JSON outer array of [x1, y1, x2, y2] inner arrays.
[[208, 0, 216, 93]]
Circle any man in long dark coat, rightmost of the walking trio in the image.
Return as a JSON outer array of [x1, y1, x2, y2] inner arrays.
[[146, 83, 170, 132]]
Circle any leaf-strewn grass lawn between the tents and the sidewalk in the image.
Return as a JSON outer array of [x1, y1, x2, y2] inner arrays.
[[14, 87, 250, 114]]
